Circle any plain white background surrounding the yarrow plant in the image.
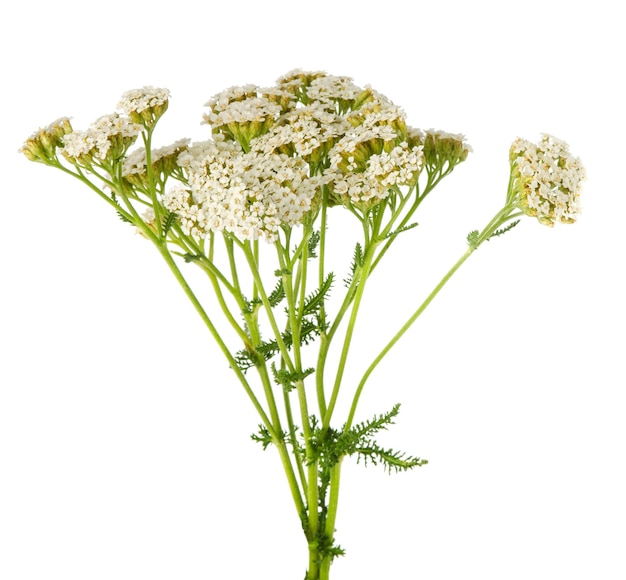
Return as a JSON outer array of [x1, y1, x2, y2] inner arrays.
[[0, 0, 626, 580]]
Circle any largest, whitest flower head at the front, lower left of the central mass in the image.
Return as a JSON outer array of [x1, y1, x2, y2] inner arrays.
[[163, 139, 321, 242]]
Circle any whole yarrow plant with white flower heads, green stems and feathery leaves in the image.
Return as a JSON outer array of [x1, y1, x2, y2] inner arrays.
[[21, 70, 585, 580]]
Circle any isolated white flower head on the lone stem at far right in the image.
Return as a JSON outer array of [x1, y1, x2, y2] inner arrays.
[[510, 134, 585, 226]]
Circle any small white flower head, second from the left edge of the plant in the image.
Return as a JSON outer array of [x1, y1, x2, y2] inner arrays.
[[61, 113, 141, 163]]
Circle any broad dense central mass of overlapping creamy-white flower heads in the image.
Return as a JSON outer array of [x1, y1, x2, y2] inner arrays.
[[162, 71, 438, 241]]
